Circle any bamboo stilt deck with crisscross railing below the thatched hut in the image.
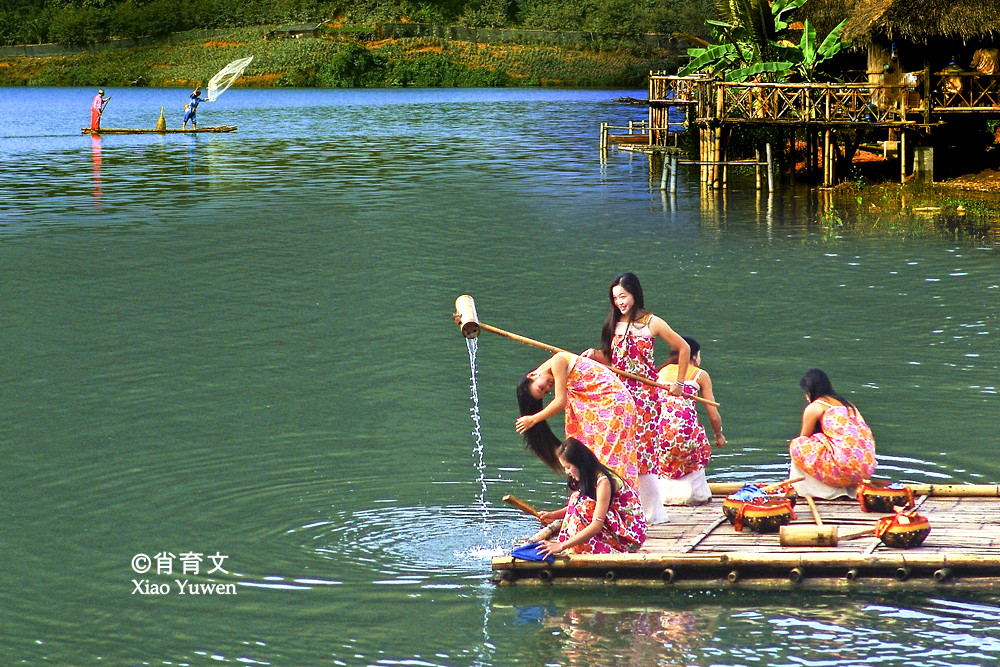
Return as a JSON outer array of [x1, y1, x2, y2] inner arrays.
[[632, 68, 1000, 189]]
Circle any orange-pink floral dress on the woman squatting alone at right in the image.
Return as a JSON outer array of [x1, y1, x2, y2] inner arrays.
[[788, 401, 876, 487]]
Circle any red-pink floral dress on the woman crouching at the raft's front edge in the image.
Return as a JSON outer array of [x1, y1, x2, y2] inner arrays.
[[559, 472, 646, 554]]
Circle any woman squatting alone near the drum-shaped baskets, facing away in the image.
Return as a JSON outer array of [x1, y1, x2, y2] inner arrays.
[[788, 368, 876, 499]]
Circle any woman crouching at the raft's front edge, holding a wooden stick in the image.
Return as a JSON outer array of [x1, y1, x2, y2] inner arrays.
[[538, 438, 646, 556]]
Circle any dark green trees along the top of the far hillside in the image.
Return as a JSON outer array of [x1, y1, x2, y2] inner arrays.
[[0, 0, 713, 47]]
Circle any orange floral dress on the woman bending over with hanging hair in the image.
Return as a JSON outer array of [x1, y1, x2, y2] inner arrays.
[[558, 352, 639, 488]]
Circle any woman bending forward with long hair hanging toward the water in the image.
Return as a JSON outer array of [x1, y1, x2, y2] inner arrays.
[[514, 352, 667, 523]]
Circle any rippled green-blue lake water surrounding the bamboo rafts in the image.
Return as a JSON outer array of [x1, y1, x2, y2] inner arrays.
[[0, 89, 1000, 667]]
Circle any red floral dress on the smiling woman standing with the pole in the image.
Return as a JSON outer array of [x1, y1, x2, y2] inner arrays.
[[611, 313, 661, 475]]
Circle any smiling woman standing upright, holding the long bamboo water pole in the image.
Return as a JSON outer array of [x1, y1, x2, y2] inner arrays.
[[583, 273, 690, 524]]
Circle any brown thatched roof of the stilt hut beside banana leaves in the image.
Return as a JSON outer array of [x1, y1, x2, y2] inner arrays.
[[836, 0, 1000, 44]]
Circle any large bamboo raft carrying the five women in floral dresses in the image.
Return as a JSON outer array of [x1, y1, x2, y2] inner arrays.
[[492, 483, 1000, 590]]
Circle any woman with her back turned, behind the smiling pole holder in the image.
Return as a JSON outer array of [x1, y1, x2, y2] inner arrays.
[[657, 336, 726, 505]]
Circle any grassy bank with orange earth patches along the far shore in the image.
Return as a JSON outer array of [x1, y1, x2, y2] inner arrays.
[[0, 27, 677, 88]]
